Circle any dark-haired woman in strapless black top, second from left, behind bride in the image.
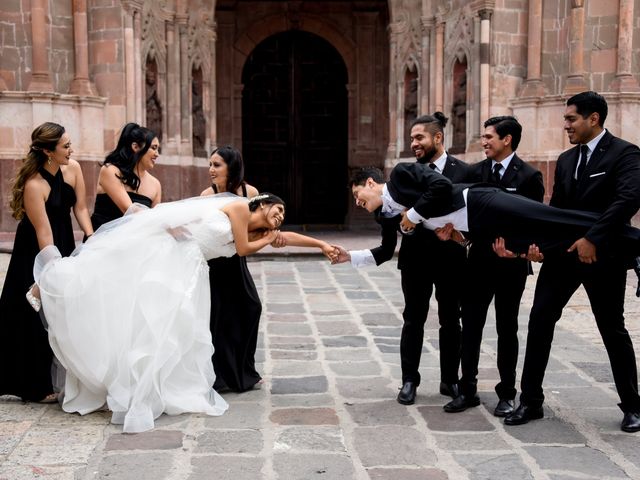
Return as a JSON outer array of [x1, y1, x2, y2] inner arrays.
[[91, 123, 162, 230]]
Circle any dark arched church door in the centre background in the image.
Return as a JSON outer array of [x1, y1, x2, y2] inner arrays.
[[242, 30, 348, 225]]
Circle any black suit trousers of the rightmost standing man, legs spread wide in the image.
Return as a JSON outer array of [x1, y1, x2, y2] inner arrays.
[[520, 254, 640, 412]]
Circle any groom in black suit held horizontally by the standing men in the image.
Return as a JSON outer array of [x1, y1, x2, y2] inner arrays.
[[334, 163, 640, 428]]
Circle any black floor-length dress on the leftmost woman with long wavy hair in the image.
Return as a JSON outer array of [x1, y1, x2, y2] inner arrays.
[[0, 169, 76, 401]]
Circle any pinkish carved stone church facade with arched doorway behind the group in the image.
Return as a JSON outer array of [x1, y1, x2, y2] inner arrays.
[[0, 0, 640, 231]]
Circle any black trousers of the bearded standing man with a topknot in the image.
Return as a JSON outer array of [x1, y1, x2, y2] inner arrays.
[[400, 246, 466, 385]]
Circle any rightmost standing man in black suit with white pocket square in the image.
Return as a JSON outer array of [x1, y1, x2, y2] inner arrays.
[[504, 92, 640, 432]]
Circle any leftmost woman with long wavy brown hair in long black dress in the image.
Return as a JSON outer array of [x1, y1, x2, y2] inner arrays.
[[0, 122, 93, 403]]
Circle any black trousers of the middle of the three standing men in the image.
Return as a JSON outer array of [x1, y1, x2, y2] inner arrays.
[[460, 246, 528, 400]]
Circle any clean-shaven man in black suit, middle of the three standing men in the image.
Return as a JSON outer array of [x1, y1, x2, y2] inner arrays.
[[444, 116, 544, 417]]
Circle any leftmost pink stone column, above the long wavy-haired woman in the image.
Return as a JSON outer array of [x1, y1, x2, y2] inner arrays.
[[27, 0, 53, 92]]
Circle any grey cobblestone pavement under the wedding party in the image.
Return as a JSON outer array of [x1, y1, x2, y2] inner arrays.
[[0, 249, 640, 480]]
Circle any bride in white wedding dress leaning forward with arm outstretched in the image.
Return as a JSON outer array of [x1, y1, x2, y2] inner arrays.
[[34, 194, 332, 432]]
